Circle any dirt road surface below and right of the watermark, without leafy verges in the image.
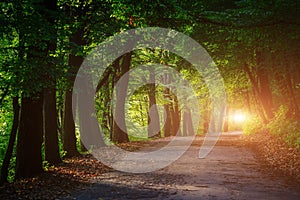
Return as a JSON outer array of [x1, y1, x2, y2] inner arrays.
[[66, 134, 300, 200]]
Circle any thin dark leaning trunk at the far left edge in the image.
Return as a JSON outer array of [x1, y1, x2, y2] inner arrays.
[[0, 97, 20, 185]]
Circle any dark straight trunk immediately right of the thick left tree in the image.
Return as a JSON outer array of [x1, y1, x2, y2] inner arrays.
[[44, 88, 62, 165]]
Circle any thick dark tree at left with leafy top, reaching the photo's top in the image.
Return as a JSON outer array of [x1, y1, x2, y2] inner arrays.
[[15, 1, 56, 179]]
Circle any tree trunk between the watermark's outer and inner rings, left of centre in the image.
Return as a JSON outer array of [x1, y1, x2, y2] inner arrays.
[[112, 52, 132, 143]]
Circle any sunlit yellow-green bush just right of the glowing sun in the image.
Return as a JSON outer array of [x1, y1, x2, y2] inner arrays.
[[242, 116, 265, 135]]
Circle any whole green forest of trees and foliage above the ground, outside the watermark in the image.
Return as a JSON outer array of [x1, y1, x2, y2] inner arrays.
[[0, 0, 300, 197]]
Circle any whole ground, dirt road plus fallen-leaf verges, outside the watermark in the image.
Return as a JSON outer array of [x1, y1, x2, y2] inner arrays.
[[0, 132, 300, 200]]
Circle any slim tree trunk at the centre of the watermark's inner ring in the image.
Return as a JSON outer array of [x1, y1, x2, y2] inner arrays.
[[148, 68, 161, 138]]
